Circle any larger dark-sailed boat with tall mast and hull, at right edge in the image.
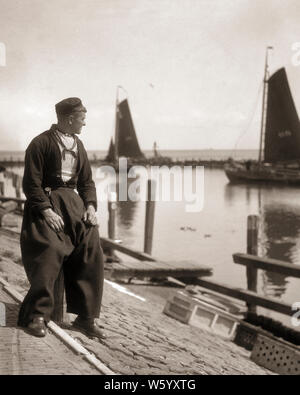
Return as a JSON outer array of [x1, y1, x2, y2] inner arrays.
[[224, 47, 300, 185]]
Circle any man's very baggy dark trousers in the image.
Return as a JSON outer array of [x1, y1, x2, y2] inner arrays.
[[18, 188, 104, 326]]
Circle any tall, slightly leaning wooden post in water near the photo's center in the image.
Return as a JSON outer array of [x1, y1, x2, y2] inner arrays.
[[144, 180, 156, 255]]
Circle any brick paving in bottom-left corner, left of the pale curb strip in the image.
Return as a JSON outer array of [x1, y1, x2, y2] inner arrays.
[[0, 286, 99, 375]]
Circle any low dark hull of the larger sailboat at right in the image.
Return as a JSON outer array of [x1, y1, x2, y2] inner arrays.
[[224, 165, 300, 186]]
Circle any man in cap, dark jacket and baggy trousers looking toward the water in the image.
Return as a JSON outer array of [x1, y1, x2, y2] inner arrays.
[[18, 98, 105, 338]]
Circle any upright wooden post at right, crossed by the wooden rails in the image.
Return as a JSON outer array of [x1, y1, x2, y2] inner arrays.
[[247, 215, 259, 313]]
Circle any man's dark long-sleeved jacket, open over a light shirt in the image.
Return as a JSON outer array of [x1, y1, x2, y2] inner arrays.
[[23, 125, 97, 211]]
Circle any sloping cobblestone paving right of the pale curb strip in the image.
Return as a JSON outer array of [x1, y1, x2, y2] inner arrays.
[[63, 283, 270, 375]]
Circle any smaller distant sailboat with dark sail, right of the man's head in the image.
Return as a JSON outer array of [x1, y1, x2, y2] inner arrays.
[[105, 86, 145, 168]]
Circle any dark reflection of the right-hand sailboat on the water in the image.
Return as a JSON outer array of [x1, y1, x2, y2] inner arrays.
[[225, 184, 300, 298]]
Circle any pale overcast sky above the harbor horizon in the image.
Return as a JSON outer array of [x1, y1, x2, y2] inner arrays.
[[0, 0, 300, 150]]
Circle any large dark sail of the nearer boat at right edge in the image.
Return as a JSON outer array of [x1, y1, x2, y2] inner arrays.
[[264, 68, 300, 163]]
